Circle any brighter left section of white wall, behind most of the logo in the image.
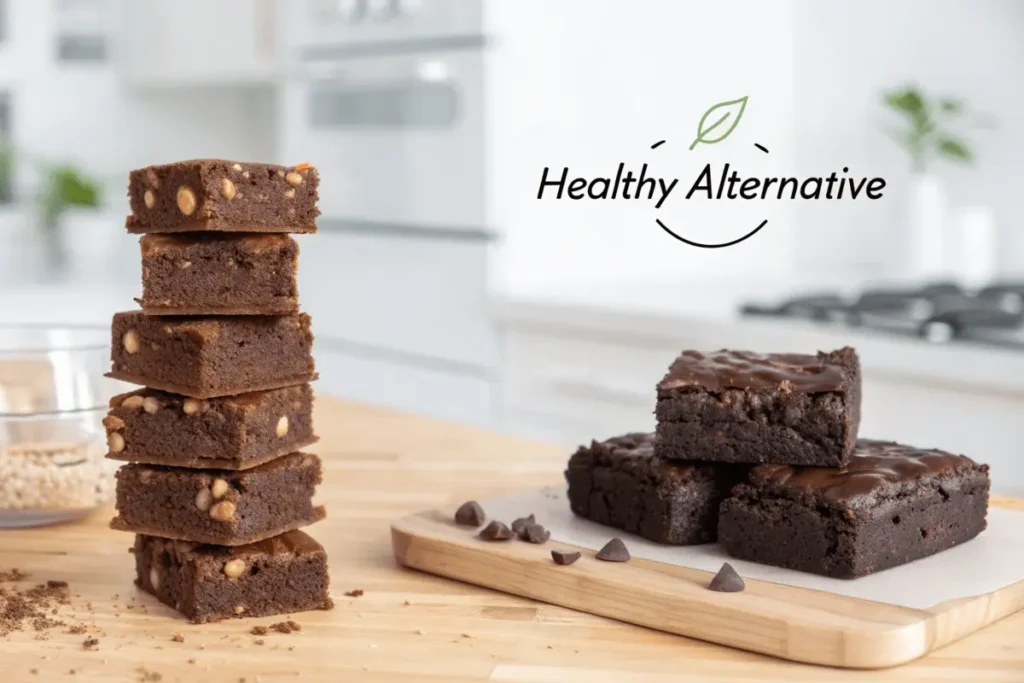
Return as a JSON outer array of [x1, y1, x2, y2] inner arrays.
[[485, 0, 794, 291]]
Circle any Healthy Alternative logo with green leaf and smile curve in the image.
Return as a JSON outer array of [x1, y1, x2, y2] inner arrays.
[[537, 95, 886, 249]]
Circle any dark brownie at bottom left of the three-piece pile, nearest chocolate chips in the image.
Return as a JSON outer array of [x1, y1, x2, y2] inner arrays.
[[565, 433, 746, 545]]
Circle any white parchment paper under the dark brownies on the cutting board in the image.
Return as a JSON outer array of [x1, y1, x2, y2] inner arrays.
[[480, 487, 1024, 609]]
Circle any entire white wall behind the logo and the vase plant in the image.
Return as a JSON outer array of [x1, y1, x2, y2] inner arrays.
[[486, 0, 1024, 292]]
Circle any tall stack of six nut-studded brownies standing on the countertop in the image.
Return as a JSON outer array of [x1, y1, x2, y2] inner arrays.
[[103, 160, 331, 623]]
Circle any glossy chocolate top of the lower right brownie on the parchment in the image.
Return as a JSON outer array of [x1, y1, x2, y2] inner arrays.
[[751, 438, 977, 501]]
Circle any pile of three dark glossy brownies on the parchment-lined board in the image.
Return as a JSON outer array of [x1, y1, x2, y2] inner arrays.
[[565, 347, 989, 579]]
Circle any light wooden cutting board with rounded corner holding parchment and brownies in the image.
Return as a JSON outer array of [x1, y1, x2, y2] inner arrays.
[[391, 493, 1024, 669]]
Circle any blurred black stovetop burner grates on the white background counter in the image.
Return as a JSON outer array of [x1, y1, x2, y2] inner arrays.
[[740, 282, 1024, 349]]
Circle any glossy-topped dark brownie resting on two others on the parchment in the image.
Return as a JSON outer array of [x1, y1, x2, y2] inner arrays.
[[654, 347, 860, 467]]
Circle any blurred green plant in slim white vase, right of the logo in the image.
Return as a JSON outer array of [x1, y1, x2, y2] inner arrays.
[[883, 86, 991, 278]]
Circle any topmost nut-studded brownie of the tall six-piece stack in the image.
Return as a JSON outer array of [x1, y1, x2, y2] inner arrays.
[[127, 159, 319, 232]]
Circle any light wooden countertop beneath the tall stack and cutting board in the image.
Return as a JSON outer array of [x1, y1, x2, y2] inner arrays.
[[0, 398, 1024, 683]]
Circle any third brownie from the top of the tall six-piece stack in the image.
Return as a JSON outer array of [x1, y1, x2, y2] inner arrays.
[[110, 310, 316, 398]]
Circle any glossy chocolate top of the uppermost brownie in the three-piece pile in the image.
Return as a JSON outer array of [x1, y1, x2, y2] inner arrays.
[[657, 349, 846, 393]]
